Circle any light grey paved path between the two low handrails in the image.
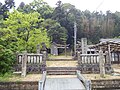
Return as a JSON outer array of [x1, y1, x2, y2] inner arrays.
[[45, 77, 85, 90]]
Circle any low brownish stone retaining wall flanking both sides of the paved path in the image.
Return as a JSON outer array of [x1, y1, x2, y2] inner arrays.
[[0, 79, 120, 90]]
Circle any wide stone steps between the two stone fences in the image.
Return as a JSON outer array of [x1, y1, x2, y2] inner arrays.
[[46, 58, 78, 75]]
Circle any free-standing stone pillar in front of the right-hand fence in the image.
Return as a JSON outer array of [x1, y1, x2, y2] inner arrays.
[[99, 49, 105, 77]]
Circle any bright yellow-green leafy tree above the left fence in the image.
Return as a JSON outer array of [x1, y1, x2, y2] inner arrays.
[[3, 10, 49, 52]]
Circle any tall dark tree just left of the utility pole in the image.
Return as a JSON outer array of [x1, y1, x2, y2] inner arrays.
[[52, 1, 76, 45]]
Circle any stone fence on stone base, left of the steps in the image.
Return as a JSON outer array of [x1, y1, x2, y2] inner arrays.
[[14, 52, 46, 75]]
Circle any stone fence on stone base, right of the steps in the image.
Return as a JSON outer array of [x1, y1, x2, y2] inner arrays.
[[78, 53, 111, 73]]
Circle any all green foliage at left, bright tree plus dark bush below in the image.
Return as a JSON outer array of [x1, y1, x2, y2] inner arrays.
[[0, 10, 49, 74]]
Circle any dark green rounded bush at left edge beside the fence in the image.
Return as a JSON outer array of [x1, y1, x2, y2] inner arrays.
[[0, 45, 15, 74]]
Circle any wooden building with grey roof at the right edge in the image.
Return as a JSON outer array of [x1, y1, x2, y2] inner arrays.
[[90, 39, 120, 64]]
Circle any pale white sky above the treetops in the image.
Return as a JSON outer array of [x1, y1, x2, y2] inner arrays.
[[0, 0, 120, 12]]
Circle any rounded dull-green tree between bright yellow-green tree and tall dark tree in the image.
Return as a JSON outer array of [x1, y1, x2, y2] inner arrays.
[[42, 19, 67, 44]]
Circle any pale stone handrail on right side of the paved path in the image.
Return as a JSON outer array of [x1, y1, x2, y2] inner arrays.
[[77, 70, 91, 90]]
